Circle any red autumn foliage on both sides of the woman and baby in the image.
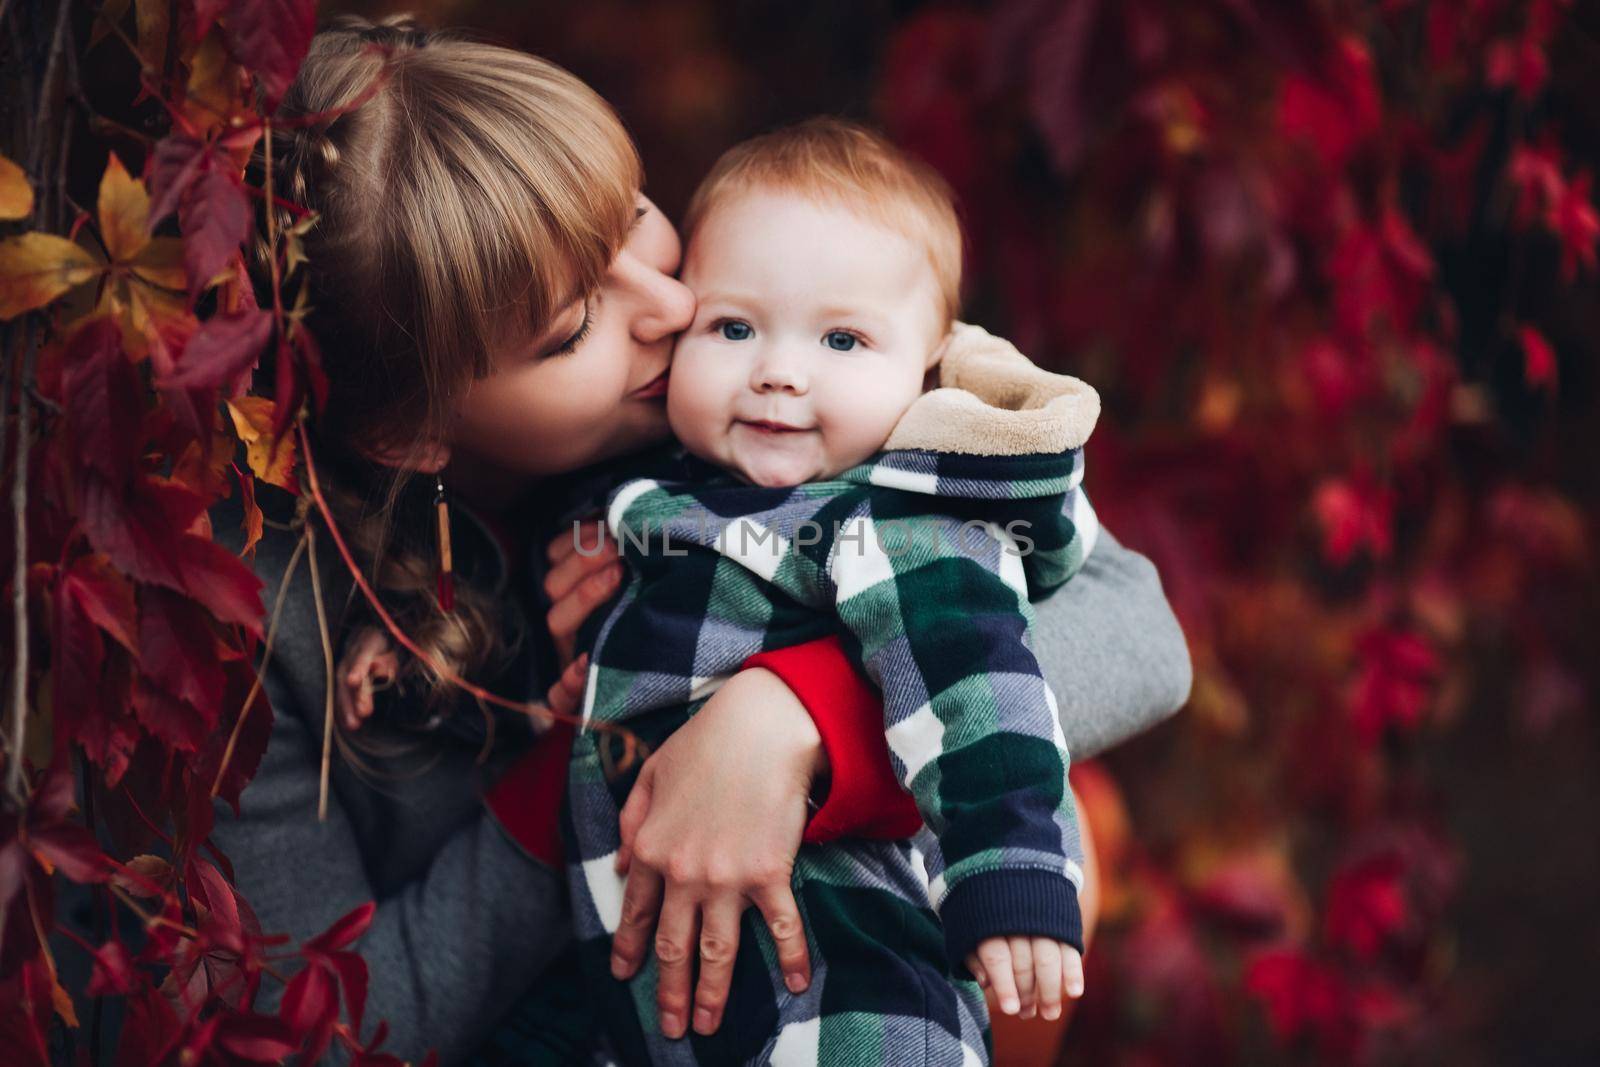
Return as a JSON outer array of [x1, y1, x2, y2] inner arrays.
[[0, 0, 1600, 1064]]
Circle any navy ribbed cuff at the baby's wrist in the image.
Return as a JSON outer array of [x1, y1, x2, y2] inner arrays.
[[939, 867, 1083, 977]]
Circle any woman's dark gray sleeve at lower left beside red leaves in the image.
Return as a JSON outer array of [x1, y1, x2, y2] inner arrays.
[[211, 657, 570, 1064]]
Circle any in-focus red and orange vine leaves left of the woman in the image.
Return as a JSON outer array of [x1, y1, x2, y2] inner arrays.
[[0, 0, 397, 1064]]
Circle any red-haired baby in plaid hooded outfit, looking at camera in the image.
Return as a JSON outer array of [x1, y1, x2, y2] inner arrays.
[[345, 120, 1099, 1064]]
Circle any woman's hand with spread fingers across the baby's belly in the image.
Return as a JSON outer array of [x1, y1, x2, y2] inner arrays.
[[611, 669, 822, 1038]]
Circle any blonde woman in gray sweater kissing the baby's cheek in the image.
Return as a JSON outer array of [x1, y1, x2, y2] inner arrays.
[[214, 21, 1189, 1064]]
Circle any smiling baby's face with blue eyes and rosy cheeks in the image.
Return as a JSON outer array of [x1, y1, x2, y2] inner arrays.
[[667, 190, 944, 486]]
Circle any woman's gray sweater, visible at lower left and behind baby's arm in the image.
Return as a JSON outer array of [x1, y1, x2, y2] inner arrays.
[[203, 470, 1190, 1064]]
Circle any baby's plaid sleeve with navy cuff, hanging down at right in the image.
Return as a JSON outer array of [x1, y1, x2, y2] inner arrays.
[[829, 510, 1083, 961]]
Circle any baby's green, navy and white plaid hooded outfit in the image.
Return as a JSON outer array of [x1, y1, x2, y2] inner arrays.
[[563, 450, 1098, 1064]]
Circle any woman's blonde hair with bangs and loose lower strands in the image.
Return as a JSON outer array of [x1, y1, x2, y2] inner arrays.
[[258, 16, 642, 710]]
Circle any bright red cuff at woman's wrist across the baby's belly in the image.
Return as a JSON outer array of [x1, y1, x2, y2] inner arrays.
[[744, 635, 922, 845]]
